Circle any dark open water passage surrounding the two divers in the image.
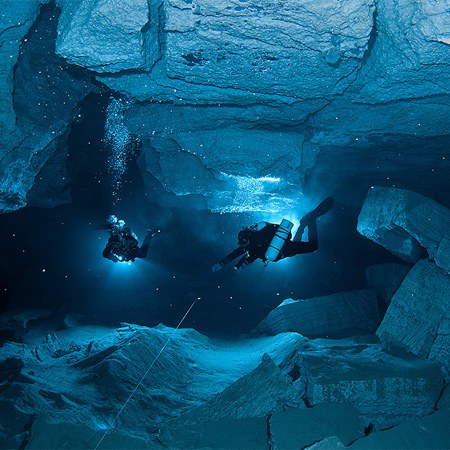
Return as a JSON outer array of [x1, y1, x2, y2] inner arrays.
[[0, 94, 406, 334]]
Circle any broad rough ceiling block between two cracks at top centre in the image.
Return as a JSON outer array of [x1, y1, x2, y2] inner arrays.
[[91, 0, 374, 103]]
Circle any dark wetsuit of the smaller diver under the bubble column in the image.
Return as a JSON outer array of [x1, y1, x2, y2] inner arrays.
[[103, 229, 153, 262]]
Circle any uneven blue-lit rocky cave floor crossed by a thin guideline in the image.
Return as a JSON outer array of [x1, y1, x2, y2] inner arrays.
[[0, 321, 447, 448]]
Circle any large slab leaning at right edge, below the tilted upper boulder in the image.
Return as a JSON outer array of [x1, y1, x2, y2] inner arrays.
[[377, 259, 450, 379]]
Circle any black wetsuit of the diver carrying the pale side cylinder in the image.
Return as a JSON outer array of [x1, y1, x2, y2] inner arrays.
[[219, 220, 319, 270]]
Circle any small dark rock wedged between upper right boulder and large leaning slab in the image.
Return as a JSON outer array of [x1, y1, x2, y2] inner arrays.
[[366, 263, 411, 305]]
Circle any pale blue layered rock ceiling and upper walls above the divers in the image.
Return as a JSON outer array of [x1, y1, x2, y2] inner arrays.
[[0, 0, 450, 211]]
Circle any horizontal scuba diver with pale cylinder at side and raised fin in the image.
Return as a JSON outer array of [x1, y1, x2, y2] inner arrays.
[[212, 197, 334, 272]]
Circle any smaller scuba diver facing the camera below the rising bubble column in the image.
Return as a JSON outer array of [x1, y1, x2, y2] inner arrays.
[[103, 215, 156, 262]]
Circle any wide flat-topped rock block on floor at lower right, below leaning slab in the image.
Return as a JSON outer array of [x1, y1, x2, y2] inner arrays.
[[298, 340, 444, 429]]
